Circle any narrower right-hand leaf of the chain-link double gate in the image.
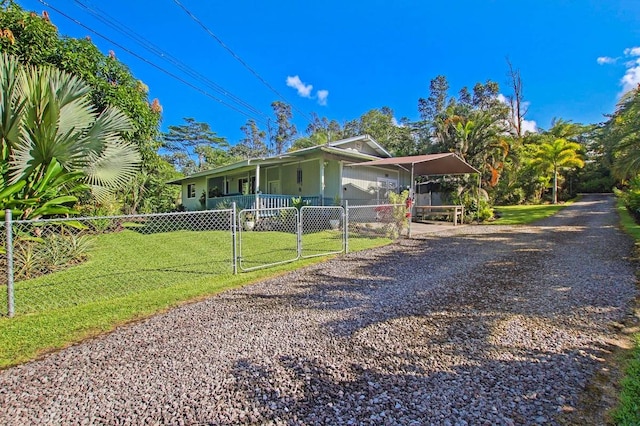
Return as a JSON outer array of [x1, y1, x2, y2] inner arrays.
[[300, 206, 345, 258]]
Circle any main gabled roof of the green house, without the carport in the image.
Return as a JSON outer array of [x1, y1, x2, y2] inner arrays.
[[167, 135, 391, 184]]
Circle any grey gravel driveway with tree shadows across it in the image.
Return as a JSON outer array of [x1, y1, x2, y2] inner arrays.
[[0, 195, 636, 425]]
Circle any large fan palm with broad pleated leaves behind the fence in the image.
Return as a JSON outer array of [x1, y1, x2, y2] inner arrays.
[[0, 54, 141, 219]]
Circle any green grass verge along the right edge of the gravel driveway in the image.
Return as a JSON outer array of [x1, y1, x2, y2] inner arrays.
[[612, 199, 640, 426]]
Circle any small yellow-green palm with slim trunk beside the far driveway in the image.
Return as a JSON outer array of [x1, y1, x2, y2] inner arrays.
[[531, 138, 584, 204]]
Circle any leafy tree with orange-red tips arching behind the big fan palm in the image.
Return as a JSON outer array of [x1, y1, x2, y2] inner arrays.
[[0, 1, 178, 213]]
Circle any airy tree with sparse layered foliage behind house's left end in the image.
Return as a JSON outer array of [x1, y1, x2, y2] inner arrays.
[[163, 117, 231, 174]]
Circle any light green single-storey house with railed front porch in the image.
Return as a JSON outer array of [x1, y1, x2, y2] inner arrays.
[[170, 135, 411, 210]]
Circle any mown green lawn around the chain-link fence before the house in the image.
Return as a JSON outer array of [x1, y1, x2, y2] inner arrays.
[[0, 226, 391, 368]]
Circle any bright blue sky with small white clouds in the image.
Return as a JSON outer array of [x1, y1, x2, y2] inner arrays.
[[13, 0, 640, 144]]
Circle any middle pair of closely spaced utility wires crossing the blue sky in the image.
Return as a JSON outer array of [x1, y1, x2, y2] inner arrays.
[[74, 0, 269, 120]]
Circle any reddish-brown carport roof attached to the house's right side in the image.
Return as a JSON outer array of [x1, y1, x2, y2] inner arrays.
[[351, 152, 480, 176]]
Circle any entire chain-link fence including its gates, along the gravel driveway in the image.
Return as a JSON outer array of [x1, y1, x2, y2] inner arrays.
[[0, 205, 407, 316]]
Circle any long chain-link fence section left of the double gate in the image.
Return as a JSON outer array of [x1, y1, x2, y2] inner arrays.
[[0, 210, 233, 314]]
